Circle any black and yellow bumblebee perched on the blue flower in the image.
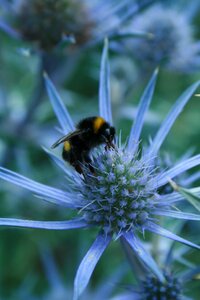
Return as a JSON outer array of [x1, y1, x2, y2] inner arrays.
[[51, 116, 115, 174]]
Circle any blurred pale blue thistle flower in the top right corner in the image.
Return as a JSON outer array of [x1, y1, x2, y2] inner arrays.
[[127, 5, 200, 72]]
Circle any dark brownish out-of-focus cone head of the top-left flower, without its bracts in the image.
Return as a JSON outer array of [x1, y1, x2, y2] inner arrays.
[[17, 0, 93, 50]]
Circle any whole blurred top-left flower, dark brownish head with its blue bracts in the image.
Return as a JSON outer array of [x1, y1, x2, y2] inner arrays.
[[0, 0, 151, 51]]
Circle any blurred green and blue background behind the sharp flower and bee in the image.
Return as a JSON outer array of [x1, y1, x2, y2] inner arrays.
[[0, 0, 200, 300]]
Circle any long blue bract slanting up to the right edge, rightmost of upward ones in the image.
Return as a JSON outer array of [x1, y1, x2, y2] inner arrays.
[[149, 81, 200, 156]]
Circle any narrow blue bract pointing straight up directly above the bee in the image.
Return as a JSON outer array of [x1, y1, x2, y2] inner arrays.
[[99, 39, 112, 124]]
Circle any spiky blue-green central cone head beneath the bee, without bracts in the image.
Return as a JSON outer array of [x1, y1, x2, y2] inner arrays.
[[77, 147, 159, 235]]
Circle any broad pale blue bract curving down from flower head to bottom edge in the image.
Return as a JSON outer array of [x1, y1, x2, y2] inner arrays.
[[73, 234, 111, 300]]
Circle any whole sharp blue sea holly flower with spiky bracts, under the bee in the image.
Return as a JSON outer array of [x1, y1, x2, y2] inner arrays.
[[0, 41, 200, 300]]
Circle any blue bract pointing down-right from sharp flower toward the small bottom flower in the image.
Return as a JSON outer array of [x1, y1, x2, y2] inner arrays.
[[123, 232, 164, 281]]
